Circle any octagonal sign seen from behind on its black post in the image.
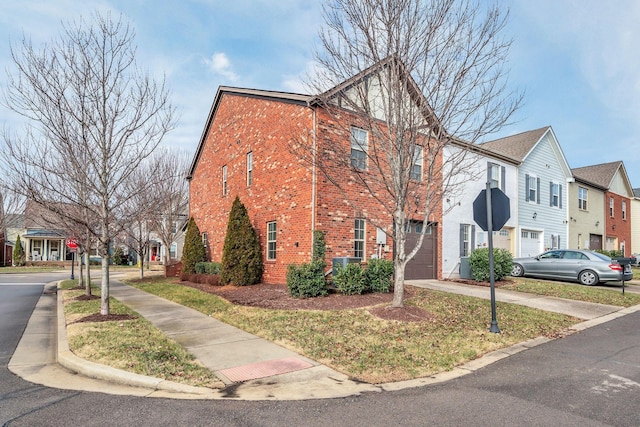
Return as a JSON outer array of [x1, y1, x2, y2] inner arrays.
[[473, 182, 511, 334]]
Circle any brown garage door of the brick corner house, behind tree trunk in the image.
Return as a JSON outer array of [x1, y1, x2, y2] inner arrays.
[[404, 221, 438, 280]]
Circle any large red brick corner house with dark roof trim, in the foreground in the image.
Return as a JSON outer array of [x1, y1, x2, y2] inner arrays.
[[187, 72, 442, 283]]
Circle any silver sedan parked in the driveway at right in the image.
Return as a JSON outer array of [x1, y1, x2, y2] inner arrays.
[[511, 249, 633, 286]]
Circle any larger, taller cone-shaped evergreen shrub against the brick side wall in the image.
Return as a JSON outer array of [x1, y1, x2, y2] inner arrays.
[[220, 196, 263, 286]]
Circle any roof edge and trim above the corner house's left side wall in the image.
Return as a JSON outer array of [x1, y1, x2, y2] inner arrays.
[[187, 86, 313, 180]]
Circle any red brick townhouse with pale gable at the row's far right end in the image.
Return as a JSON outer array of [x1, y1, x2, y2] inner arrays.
[[573, 161, 634, 256]]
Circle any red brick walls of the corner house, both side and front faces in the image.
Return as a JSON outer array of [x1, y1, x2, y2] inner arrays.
[[190, 93, 442, 283]]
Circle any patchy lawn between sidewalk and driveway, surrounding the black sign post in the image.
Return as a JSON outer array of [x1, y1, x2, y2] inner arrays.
[[129, 279, 579, 383]]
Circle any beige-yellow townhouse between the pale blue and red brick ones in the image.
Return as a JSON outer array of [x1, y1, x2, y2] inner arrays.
[[568, 176, 607, 250]]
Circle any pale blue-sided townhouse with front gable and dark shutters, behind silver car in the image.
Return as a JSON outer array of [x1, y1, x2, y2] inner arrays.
[[480, 126, 573, 257]]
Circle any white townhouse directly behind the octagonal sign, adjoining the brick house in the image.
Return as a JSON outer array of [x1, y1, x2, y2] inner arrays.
[[442, 143, 520, 278]]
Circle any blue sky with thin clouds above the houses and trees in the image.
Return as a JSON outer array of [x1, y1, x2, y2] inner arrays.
[[0, 0, 640, 187]]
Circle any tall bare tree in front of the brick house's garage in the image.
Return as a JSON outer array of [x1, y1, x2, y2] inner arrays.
[[301, 0, 522, 307]]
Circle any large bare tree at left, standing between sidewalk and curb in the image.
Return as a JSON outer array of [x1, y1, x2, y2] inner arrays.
[[4, 14, 175, 315]]
